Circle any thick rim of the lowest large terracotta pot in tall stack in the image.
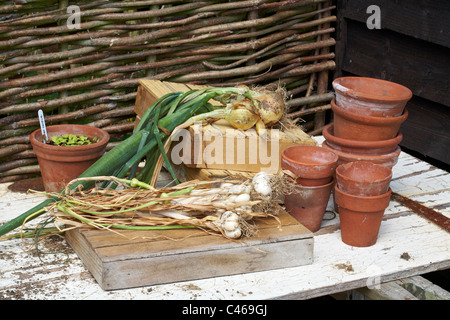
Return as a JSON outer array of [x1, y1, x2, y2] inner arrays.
[[322, 123, 403, 155]]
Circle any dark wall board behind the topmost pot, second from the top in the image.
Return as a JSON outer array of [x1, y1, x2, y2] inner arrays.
[[342, 20, 450, 106]]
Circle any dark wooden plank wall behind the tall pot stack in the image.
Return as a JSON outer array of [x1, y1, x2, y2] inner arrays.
[[334, 0, 450, 165]]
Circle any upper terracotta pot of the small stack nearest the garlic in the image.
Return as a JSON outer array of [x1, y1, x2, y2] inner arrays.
[[281, 145, 338, 186]]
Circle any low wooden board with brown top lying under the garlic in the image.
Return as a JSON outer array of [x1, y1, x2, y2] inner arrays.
[[66, 212, 314, 290]]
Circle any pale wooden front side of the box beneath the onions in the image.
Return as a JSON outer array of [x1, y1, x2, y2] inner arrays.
[[182, 120, 316, 174]]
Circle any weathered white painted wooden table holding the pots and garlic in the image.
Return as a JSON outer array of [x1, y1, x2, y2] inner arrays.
[[0, 138, 450, 300]]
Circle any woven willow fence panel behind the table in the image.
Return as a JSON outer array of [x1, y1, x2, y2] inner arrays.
[[0, 0, 336, 182]]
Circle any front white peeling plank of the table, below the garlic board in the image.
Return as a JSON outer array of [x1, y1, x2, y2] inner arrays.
[[0, 208, 450, 299]]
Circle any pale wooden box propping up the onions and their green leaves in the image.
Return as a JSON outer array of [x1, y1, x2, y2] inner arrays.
[[134, 79, 317, 178]]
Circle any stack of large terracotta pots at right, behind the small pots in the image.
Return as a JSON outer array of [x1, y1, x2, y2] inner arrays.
[[322, 77, 412, 168]]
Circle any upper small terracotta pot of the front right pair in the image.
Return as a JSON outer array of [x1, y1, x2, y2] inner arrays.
[[336, 161, 392, 196]]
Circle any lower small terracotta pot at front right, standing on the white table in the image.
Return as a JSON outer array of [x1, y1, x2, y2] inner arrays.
[[334, 185, 391, 247]]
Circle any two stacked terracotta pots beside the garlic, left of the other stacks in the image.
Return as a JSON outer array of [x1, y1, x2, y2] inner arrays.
[[281, 145, 338, 232]]
